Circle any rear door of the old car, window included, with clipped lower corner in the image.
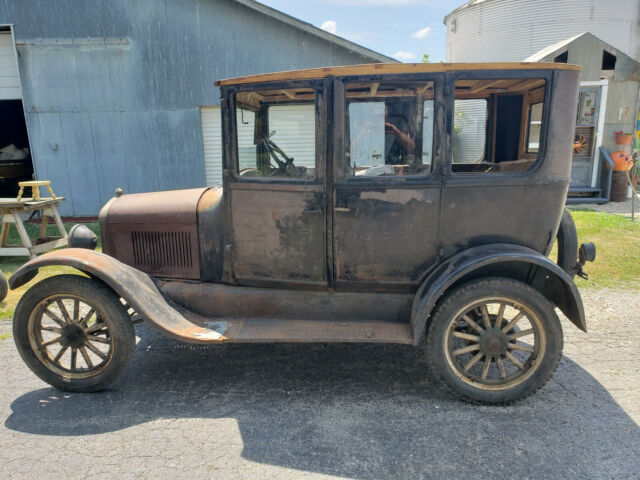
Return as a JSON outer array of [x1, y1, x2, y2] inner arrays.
[[332, 76, 444, 291]]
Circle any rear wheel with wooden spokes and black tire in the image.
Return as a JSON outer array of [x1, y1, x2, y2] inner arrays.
[[426, 278, 563, 404]]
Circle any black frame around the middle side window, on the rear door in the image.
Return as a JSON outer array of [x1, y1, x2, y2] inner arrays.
[[333, 73, 444, 185]]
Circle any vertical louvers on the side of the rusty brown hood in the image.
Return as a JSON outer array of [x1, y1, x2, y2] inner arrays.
[[131, 230, 193, 271]]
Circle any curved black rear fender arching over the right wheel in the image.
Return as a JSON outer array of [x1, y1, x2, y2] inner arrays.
[[411, 243, 587, 344]]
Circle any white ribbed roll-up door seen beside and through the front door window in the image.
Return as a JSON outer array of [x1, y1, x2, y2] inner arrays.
[[200, 105, 315, 185]]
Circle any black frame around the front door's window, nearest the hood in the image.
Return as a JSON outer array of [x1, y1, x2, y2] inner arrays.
[[223, 80, 327, 185]]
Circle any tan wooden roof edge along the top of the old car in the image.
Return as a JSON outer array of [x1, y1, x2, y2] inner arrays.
[[215, 62, 580, 87]]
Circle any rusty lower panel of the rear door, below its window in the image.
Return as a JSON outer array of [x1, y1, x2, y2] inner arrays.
[[334, 186, 440, 289]]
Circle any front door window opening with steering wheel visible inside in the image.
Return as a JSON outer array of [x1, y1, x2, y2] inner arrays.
[[236, 88, 316, 180]]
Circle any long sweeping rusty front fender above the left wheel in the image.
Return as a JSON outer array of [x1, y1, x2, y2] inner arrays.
[[9, 248, 220, 343]]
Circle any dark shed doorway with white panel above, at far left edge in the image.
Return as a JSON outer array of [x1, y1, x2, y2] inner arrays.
[[0, 27, 33, 198]]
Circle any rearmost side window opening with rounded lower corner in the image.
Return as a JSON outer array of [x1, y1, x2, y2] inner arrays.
[[451, 78, 545, 174]]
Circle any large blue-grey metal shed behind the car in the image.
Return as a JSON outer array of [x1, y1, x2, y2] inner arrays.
[[0, 0, 395, 216]]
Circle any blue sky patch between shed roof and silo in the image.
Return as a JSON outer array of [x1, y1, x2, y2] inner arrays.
[[259, 0, 466, 62]]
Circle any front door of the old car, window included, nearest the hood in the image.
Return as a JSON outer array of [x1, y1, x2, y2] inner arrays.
[[225, 82, 327, 286]]
